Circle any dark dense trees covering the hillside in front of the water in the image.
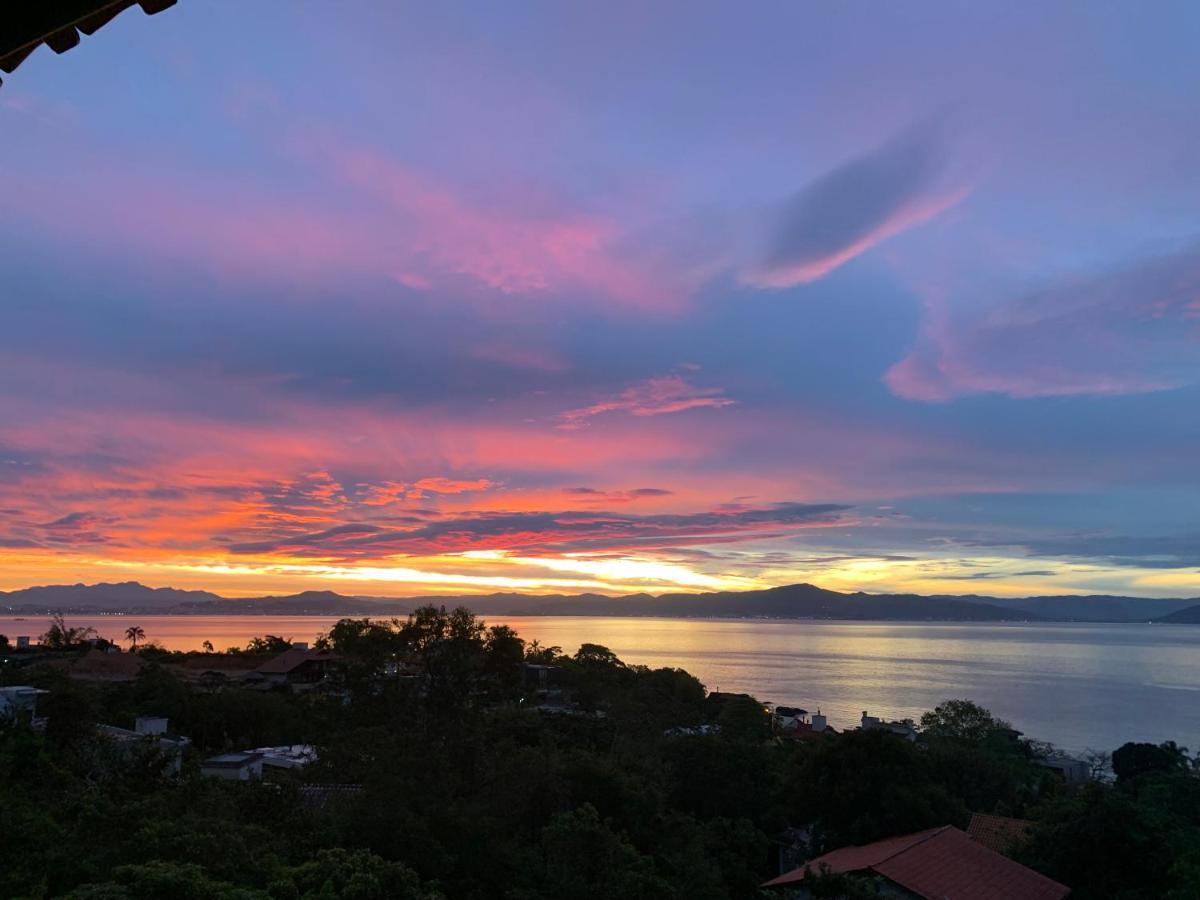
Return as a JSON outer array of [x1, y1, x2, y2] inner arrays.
[[0, 607, 1200, 900]]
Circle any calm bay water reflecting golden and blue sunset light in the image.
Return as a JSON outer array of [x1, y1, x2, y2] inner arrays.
[[0, 616, 1200, 751]]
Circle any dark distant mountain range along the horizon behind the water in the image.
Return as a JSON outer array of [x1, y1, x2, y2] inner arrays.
[[0, 581, 1200, 624]]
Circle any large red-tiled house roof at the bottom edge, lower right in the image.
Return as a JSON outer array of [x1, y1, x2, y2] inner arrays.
[[763, 826, 1070, 900]]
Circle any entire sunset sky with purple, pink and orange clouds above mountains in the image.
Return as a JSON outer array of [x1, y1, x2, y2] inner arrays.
[[0, 0, 1200, 596]]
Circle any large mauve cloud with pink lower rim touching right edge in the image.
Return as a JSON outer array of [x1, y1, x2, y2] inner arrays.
[[886, 246, 1200, 402]]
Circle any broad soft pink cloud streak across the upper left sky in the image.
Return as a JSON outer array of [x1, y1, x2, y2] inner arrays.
[[0, 127, 682, 307]]
